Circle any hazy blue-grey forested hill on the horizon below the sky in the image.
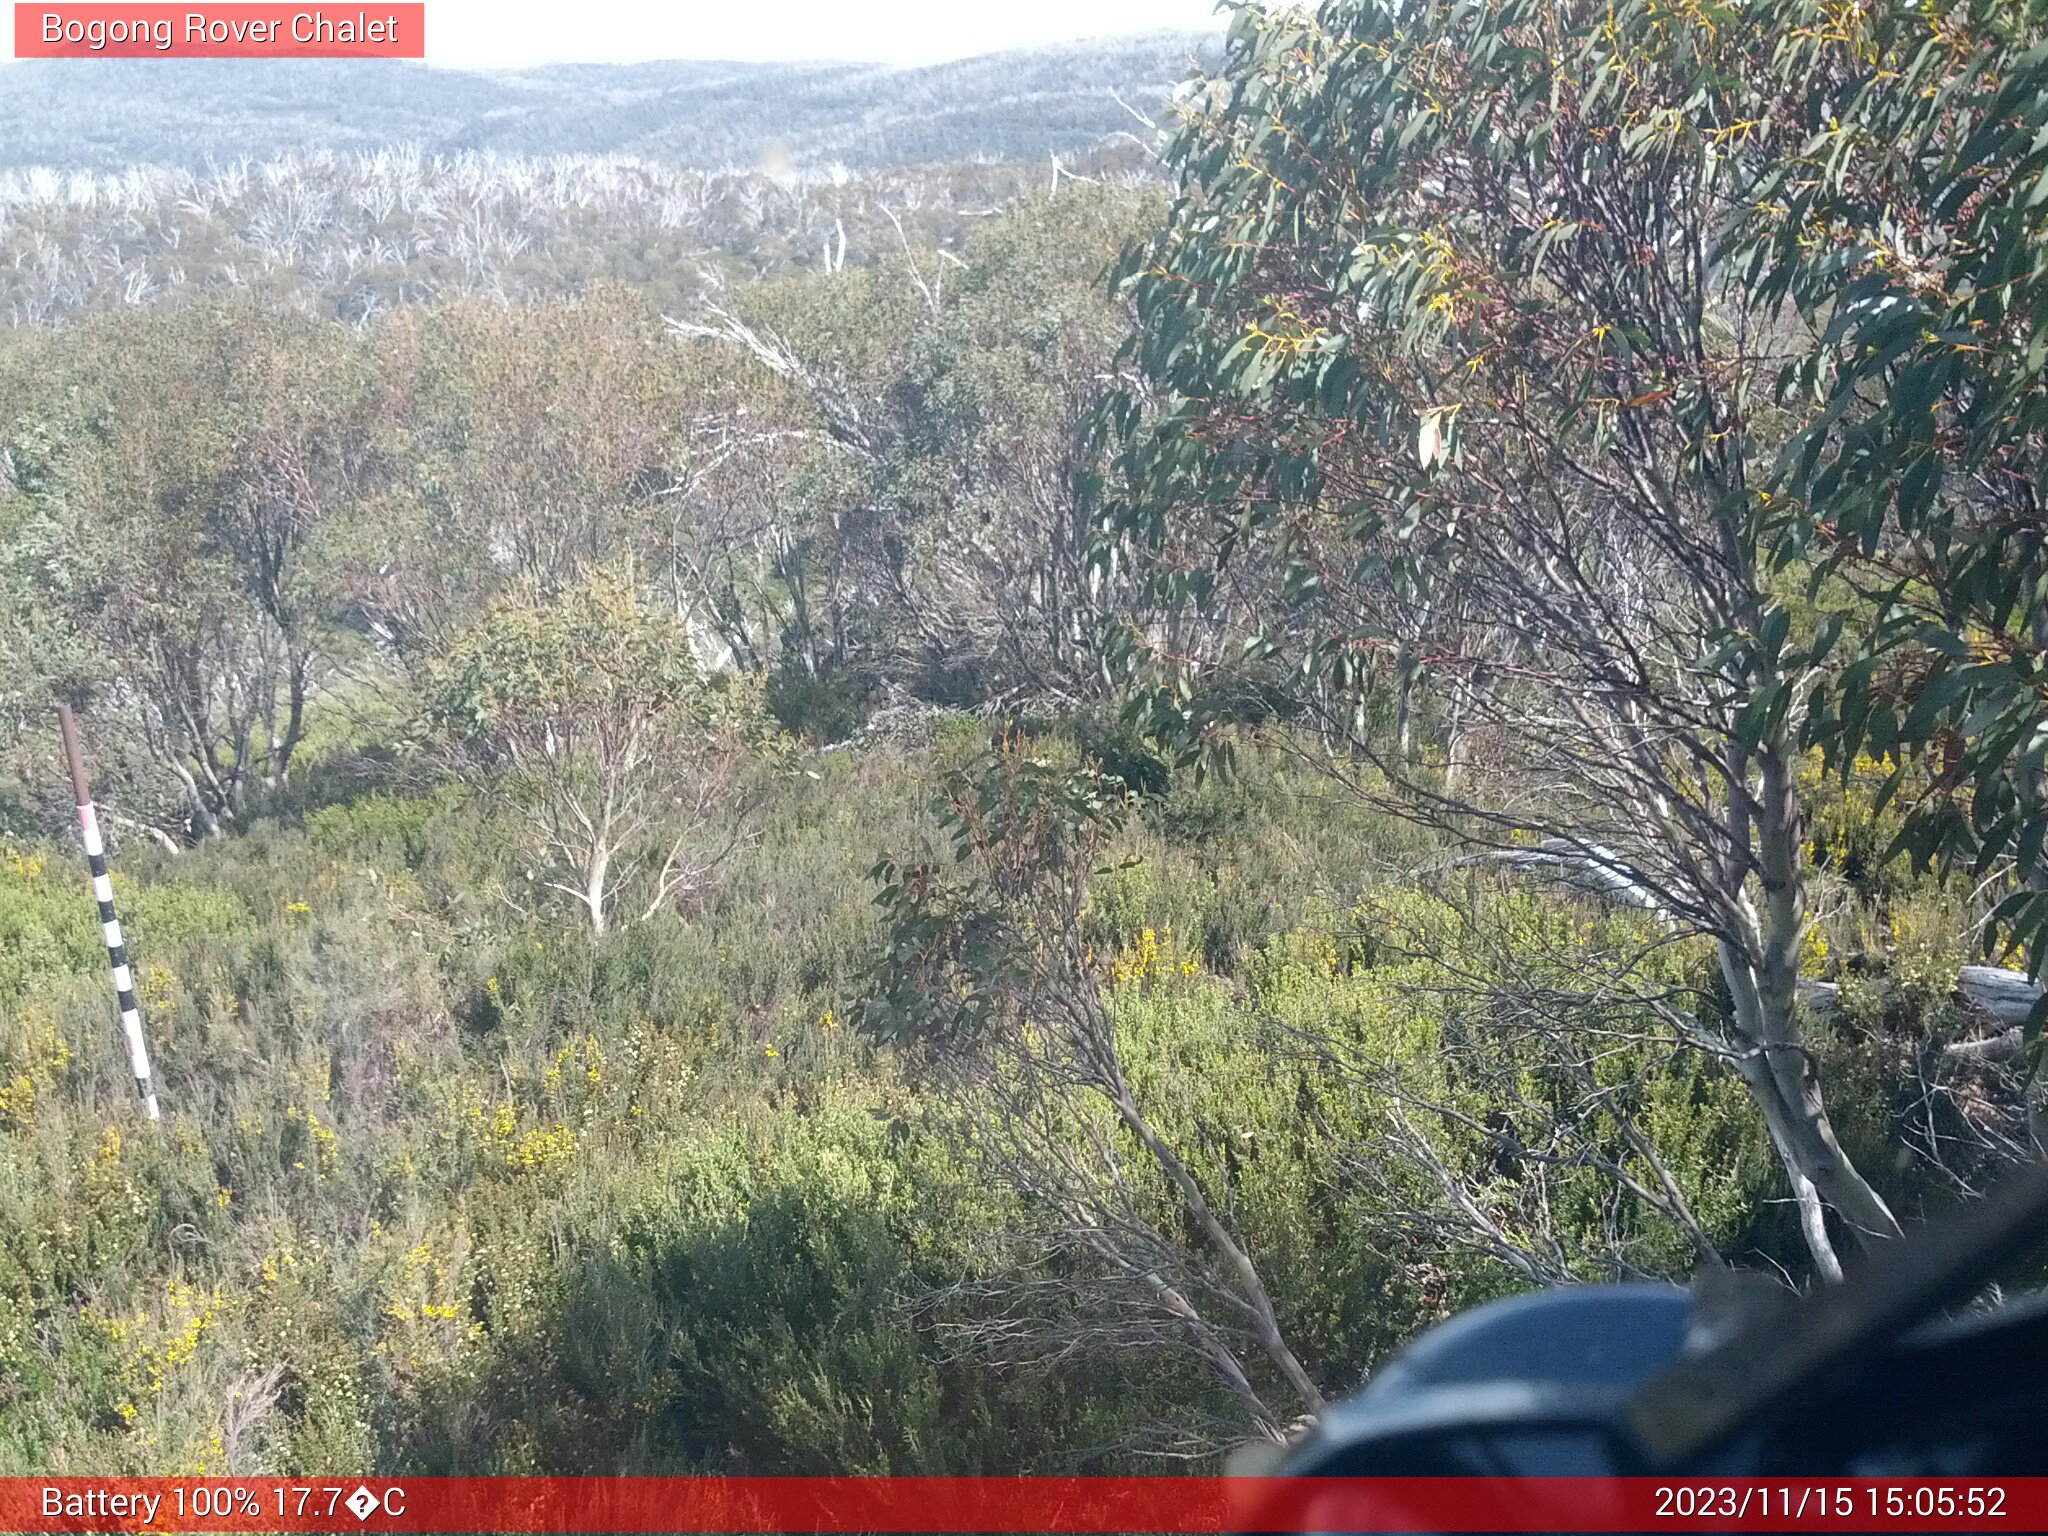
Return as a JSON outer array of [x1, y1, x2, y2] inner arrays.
[[0, 33, 1221, 170]]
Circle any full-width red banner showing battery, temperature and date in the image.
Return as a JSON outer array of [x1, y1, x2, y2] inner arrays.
[[0, 1477, 2048, 1536]]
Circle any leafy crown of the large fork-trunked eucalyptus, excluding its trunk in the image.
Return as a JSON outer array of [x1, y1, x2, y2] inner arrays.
[[1094, 0, 1826, 752]]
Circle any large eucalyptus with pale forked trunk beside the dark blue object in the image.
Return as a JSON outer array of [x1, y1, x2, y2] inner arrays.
[[1102, 0, 1898, 1274]]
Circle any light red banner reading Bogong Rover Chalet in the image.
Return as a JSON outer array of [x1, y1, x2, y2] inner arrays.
[[14, 0, 426, 59]]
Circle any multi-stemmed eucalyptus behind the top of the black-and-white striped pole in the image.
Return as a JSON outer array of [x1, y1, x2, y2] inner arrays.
[[4, 301, 373, 836]]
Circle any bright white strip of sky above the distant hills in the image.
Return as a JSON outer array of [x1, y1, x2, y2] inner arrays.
[[426, 0, 1223, 70]]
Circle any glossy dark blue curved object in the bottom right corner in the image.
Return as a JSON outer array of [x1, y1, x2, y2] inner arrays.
[[1278, 1286, 2048, 1499]]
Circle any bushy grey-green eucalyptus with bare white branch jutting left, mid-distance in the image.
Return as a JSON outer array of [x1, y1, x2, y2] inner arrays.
[[678, 186, 1147, 705]]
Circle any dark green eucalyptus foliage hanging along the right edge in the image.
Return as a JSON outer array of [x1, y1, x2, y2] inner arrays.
[[1733, 0, 2048, 999]]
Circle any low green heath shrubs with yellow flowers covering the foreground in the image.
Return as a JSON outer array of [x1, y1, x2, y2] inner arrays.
[[0, 704, 1998, 1473]]
